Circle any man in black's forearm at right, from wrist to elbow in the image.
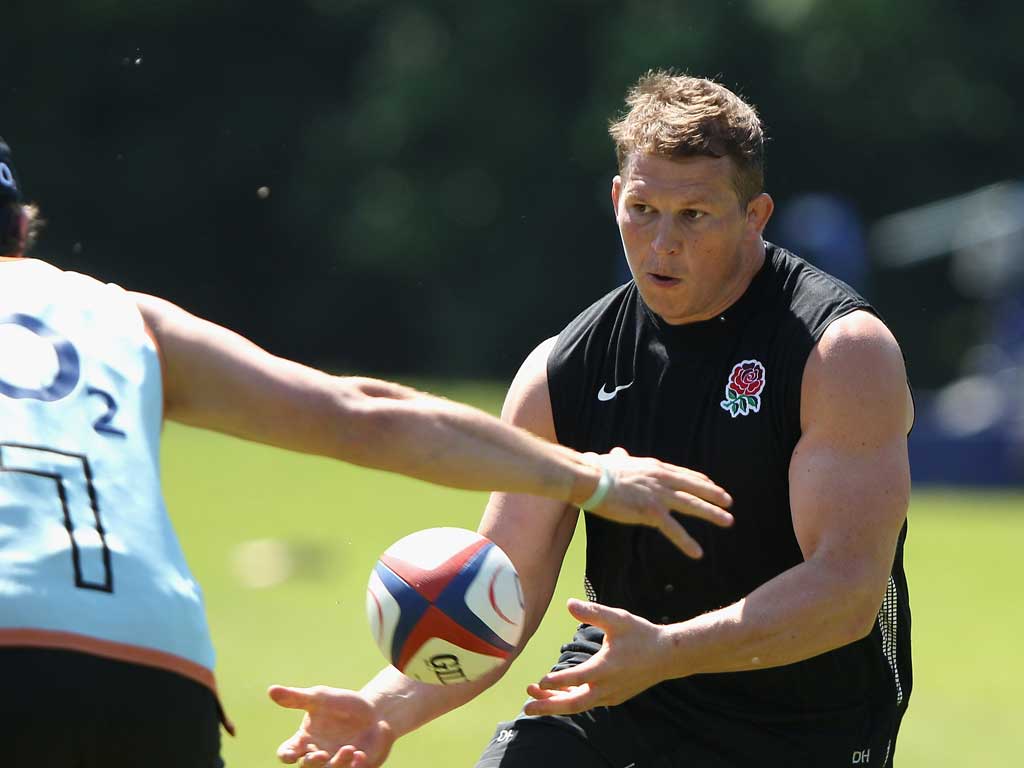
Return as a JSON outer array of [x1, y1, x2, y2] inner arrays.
[[664, 560, 884, 677]]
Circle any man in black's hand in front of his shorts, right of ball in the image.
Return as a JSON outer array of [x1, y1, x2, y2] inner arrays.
[[524, 600, 665, 715]]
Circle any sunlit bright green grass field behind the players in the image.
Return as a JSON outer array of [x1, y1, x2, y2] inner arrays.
[[163, 386, 1024, 768]]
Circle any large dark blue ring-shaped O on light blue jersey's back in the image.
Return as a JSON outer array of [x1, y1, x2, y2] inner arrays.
[[0, 314, 81, 402]]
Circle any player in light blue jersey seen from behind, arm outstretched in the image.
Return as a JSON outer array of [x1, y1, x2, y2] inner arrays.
[[0, 141, 731, 768]]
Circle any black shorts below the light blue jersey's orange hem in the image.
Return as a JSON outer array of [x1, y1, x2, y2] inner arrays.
[[0, 647, 223, 768]]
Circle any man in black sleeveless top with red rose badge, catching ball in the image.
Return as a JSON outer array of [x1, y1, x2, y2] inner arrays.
[[270, 73, 912, 768]]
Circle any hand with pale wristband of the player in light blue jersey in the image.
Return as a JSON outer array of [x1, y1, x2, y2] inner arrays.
[[588, 447, 732, 557]]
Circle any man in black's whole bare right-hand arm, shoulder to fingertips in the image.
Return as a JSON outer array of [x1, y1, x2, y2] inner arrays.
[[527, 312, 912, 714]]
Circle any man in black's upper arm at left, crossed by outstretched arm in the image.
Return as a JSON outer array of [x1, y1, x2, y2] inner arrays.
[[479, 339, 579, 640]]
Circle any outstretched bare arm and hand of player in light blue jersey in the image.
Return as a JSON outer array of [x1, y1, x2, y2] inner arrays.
[[135, 294, 730, 540]]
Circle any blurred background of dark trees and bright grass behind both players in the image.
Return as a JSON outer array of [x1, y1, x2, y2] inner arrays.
[[0, 0, 1024, 767]]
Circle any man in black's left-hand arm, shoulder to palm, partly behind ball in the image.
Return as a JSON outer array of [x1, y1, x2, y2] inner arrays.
[[270, 343, 577, 768]]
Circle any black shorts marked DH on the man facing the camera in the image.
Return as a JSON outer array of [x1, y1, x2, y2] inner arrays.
[[476, 627, 899, 768]]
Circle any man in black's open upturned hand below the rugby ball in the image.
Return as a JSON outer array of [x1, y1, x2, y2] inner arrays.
[[267, 685, 395, 768]]
